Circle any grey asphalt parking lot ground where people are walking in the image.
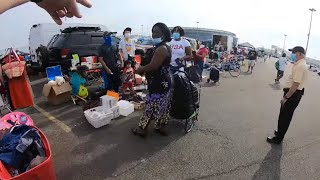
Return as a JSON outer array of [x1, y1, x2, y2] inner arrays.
[[25, 59, 320, 180]]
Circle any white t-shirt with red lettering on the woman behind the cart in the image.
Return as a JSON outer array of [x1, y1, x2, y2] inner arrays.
[[170, 39, 191, 66]]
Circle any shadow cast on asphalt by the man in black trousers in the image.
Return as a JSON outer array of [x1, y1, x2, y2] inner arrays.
[[252, 145, 282, 180]]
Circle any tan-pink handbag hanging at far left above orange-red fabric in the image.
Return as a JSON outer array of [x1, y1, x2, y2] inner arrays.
[[2, 49, 26, 79]]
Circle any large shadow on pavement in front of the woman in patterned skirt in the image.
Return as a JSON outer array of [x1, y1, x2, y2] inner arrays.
[[57, 117, 184, 180]]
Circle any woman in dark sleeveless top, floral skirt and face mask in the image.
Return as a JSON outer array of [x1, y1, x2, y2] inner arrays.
[[132, 23, 173, 137]]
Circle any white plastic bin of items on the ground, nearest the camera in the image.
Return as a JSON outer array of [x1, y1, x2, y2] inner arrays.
[[84, 106, 114, 128]]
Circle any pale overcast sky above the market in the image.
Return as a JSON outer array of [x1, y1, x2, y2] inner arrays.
[[0, 0, 320, 59]]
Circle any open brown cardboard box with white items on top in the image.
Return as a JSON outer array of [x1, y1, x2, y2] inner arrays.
[[42, 83, 72, 105]]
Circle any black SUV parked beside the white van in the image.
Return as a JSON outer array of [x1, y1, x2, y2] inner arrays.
[[41, 27, 120, 70]]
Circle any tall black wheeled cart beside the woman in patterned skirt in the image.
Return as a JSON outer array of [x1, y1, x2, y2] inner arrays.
[[170, 71, 201, 133]]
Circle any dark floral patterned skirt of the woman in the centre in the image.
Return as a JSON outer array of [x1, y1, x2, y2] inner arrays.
[[139, 89, 173, 129]]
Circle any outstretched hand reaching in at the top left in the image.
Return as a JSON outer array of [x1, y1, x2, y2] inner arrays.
[[38, 0, 92, 25]]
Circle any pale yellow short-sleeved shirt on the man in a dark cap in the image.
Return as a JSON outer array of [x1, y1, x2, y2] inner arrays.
[[286, 59, 308, 90]]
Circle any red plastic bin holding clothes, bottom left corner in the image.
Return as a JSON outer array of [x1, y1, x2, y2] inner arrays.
[[0, 127, 57, 180]]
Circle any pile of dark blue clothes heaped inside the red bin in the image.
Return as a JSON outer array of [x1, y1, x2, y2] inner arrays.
[[0, 125, 47, 177]]
